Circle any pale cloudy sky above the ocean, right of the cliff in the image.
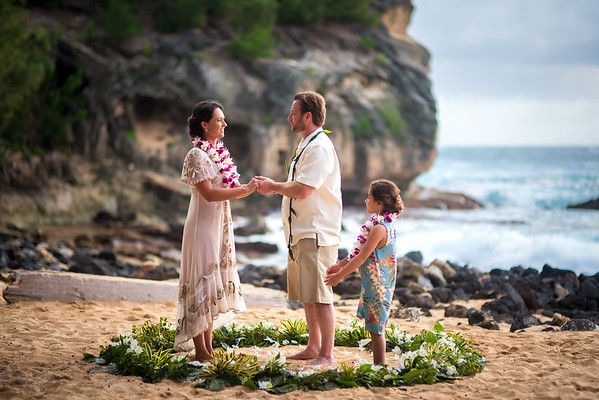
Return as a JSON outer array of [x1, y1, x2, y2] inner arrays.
[[408, 0, 599, 146]]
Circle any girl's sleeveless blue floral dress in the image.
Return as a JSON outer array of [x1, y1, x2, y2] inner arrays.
[[357, 221, 397, 334]]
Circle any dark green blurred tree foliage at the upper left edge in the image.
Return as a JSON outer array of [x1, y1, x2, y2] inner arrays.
[[0, 0, 85, 159]]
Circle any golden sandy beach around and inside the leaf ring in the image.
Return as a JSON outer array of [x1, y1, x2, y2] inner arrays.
[[0, 287, 599, 399]]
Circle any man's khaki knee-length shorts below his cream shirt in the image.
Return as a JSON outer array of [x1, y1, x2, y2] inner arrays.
[[287, 239, 338, 304]]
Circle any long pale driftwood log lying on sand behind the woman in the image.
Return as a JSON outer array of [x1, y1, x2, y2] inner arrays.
[[3, 271, 287, 307]]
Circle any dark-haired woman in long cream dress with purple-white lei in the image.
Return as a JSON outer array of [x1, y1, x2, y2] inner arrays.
[[175, 100, 258, 361]]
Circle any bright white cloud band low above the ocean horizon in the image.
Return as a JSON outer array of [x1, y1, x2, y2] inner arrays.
[[439, 97, 599, 146]]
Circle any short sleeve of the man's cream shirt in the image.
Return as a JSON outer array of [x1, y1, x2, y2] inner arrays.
[[295, 145, 335, 189]]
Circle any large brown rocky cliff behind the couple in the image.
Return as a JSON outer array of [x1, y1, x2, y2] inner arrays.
[[2, 0, 437, 225]]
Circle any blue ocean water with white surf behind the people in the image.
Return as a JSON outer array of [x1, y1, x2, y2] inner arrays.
[[238, 147, 599, 274]]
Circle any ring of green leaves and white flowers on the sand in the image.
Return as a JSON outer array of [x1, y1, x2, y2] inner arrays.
[[83, 318, 488, 393]]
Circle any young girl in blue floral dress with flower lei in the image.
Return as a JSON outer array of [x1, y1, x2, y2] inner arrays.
[[325, 179, 404, 365]]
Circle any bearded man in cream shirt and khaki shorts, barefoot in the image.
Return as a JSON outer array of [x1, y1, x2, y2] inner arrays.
[[257, 92, 342, 364]]
